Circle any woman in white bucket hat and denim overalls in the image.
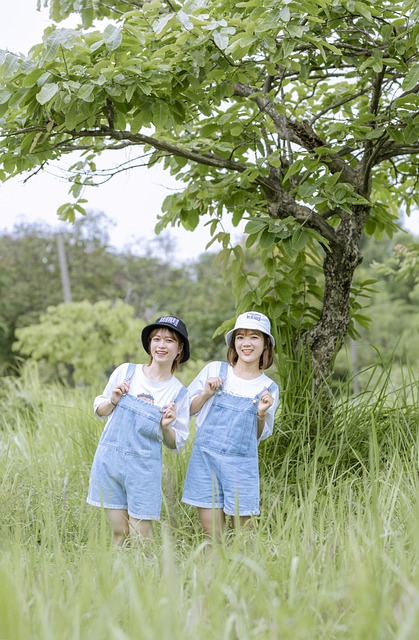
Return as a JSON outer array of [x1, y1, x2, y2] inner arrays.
[[182, 311, 279, 540]]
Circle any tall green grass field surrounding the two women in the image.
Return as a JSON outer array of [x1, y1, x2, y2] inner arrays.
[[0, 362, 419, 640]]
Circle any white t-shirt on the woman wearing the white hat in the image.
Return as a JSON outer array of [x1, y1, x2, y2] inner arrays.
[[188, 361, 279, 440]]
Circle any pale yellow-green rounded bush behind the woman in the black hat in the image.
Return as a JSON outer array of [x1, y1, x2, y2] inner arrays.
[[13, 300, 146, 384]]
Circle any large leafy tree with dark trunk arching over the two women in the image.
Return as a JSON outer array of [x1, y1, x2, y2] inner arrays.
[[0, 0, 419, 396]]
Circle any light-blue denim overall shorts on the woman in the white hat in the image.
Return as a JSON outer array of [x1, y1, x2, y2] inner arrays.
[[182, 362, 276, 516]]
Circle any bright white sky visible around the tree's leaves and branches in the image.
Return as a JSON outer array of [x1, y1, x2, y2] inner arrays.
[[0, 0, 419, 261]]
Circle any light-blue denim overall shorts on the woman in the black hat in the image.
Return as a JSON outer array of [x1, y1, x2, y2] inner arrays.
[[87, 364, 187, 520]]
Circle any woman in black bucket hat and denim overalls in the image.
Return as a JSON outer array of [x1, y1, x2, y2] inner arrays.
[[87, 316, 190, 545]]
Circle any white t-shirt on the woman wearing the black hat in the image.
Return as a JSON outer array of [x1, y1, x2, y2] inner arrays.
[[93, 362, 190, 451]]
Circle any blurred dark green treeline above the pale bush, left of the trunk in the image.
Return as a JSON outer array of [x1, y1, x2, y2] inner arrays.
[[0, 211, 235, 371]]
